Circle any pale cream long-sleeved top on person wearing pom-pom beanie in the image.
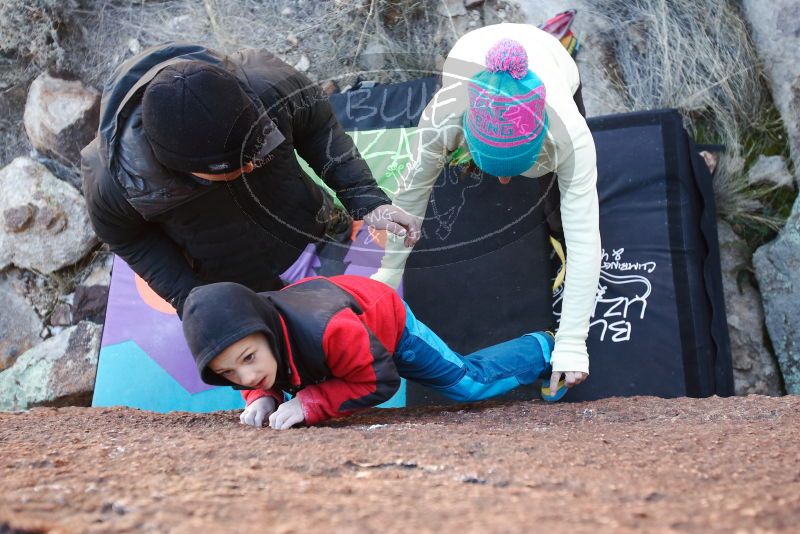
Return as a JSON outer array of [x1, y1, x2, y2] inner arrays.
[[372, 23, 600, 373]]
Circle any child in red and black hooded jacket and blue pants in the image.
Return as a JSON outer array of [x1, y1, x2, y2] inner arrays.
[[183, 275, 553, 429]]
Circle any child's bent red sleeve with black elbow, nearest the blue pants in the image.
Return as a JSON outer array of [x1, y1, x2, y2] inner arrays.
[[298, 309, 400, 425]]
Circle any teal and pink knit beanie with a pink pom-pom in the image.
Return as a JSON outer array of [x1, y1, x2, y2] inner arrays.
[[464, 39, 548, 176]]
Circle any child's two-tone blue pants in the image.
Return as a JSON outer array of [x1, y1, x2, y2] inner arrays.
[[394, 304, 554, 402]]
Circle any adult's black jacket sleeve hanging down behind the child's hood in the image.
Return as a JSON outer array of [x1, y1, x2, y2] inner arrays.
[[82, 145, 202, 315]]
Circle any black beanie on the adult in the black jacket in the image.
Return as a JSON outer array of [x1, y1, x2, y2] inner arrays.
[[142, 61, 272, 174]]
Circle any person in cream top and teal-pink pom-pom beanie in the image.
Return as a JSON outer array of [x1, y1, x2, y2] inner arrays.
[[372, 23, 601, 392]]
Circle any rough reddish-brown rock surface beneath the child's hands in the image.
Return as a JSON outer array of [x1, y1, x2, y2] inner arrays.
[[0, 396, 800, 534]]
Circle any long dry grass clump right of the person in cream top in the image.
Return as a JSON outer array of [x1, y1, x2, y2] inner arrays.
[[596, 0, 786, 236]]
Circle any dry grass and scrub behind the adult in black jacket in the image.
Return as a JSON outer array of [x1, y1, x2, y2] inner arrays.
[[0, 0, 466, 165]]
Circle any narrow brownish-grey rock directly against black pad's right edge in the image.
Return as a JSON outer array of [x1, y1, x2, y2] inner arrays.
[[717, 220, 782, 395]]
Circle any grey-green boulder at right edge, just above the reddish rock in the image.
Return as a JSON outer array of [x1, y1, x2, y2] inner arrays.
[[753, 197, 800, 395]]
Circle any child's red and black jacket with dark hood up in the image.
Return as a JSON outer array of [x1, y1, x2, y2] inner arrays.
[[183, 275, 406, 424]]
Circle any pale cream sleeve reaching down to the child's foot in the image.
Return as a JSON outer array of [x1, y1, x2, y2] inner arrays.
[[551, 111, 601, 378]]
